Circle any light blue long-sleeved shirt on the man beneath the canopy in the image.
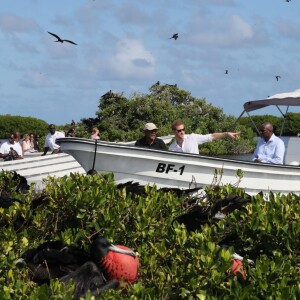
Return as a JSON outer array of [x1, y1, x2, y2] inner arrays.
[[252, 133, 285, 165]]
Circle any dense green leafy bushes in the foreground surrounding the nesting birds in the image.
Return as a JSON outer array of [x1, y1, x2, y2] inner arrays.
[[0, 172, 300, 300]]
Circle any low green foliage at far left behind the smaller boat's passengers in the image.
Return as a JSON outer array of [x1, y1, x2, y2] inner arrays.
[[0, 115, 48, 139]]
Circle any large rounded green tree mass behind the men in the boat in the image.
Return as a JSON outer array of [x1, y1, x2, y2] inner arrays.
[[81, 82, 253, 155]]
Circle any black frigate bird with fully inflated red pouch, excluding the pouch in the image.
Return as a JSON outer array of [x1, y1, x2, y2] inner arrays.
[[16, 237, 136, 299]]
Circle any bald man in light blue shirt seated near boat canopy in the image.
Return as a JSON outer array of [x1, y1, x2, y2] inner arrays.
[[252, 122, 285, 165]]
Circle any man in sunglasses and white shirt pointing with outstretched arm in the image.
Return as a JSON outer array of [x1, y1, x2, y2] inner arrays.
[[169, 120, 240, 154]]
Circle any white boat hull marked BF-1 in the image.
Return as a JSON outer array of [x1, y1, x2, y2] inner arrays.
[[57, 138, 300, 195]]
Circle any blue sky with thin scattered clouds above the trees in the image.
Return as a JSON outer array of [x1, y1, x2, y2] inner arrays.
[[0, 0, 300, 125]]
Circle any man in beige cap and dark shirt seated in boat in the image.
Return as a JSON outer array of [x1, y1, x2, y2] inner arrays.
[[135, 123, 167, 150]]
